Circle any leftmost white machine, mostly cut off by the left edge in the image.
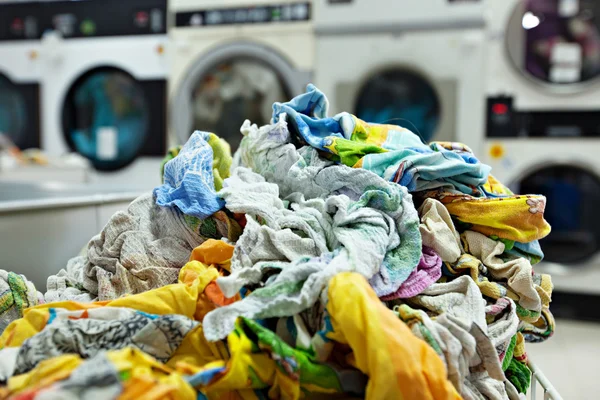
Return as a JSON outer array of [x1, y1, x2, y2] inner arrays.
[[0, 2, 41, 149]]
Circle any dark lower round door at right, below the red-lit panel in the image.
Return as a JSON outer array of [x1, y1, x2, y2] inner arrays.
[[514, 165, 600, 265]]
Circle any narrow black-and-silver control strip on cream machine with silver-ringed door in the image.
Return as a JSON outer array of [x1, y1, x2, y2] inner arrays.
[[175, 2, 311, 27]]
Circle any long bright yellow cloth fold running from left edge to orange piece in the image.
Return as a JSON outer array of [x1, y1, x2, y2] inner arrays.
[[0, 262, 218, 348]]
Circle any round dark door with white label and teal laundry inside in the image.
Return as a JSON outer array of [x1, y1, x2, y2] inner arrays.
[[62, 68, 151, 171]]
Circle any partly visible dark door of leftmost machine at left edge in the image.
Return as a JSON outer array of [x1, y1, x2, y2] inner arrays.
[[0, 74, 39, 149]]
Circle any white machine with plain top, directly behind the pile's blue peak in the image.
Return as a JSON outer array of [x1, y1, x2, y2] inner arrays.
[[315, 0, 485, 150]]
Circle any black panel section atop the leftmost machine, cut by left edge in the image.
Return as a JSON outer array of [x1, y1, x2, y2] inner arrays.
[[0, 3, 41, 41]]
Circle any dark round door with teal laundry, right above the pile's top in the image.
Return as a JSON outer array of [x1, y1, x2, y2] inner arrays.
[[354, 68, 442, 143]]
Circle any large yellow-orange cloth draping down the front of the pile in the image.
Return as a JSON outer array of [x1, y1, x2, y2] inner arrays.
[[327, 272, 461, 400]]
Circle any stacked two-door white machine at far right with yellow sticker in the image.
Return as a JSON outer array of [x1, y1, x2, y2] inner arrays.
[[483, 0, 600, 294]]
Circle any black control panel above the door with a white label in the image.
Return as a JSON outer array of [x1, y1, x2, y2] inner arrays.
[[42, 0, 167, 39]]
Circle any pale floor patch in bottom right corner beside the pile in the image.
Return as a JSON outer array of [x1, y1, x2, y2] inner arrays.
[[527, 320, 600, 400]]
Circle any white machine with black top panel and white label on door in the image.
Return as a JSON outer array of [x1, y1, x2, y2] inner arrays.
[[42, 0, 168, 189]]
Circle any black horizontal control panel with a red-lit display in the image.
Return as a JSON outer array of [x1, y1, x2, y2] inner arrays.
[[486, 96, 600, 138]]
